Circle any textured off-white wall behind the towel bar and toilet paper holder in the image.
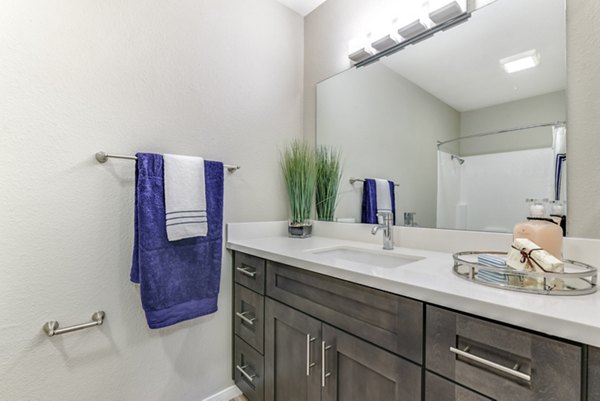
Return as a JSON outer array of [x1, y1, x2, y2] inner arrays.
[[0, 0, 303, 401]]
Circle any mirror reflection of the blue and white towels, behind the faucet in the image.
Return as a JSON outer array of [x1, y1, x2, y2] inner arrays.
[[361, 178, 396, 224]]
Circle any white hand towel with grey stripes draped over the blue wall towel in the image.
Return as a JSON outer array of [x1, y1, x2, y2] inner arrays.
[[163, 155, 208, 241]]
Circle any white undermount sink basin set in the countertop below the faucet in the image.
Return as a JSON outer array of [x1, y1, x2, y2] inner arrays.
[[311, 247, 423, 267]]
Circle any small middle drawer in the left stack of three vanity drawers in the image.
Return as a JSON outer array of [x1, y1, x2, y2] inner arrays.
[[233, 284, 265, 354]]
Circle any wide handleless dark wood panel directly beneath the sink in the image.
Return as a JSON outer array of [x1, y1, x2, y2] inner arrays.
[[267, 262, 423, 363]]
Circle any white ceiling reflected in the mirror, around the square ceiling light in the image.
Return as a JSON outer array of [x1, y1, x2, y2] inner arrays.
[[381, 0, 566, 112]]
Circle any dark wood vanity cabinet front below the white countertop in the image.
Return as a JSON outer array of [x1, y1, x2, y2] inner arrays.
[[233, 252, 588, 401]]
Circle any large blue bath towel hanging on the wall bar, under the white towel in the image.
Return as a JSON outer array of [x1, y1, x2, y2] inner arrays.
[[131, 153, 223, 329]]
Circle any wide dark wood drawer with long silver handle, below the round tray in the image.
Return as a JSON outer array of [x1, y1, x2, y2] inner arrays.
[[426, 306, 582, 401]]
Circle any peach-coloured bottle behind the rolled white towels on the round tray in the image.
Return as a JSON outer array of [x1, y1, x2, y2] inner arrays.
[[513, 199, 563, 259]]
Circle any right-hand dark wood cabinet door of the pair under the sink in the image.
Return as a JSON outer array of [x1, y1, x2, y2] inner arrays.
[[322, 324, 421, 401]]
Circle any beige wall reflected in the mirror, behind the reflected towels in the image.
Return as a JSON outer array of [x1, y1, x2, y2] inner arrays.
[[317, 63, 460, 227]]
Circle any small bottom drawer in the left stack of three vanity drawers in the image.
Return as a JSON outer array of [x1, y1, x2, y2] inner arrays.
[[233, 336, 264, 401]]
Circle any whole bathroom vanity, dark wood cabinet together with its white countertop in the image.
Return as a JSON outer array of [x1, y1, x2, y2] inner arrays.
[[228, 222, 600, 401]]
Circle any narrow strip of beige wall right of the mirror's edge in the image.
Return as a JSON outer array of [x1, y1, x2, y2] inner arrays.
[[567, 0, 600, 238]]
